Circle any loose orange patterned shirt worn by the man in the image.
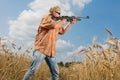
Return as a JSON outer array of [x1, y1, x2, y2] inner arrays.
[[34, 15, 65, 57]]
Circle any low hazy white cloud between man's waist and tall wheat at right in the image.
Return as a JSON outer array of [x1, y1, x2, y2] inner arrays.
[[57, 40, 85, 62]]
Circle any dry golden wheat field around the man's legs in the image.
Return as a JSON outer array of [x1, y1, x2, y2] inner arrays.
[[0, 30, 120, 80]]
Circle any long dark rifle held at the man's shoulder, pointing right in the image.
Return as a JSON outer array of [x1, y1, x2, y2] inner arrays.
[[52, 16, 90, 22]]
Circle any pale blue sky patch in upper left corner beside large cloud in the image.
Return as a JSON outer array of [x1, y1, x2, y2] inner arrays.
[[0, 0, 32, 37]]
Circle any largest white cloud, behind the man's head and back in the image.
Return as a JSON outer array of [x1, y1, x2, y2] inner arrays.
[[9, 0, 91, 40]]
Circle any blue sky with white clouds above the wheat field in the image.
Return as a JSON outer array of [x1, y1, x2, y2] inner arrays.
[[0, 0, 120, 61]]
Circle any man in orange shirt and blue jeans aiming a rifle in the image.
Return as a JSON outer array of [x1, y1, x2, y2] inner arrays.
[[23, 6, 77, 80]]
